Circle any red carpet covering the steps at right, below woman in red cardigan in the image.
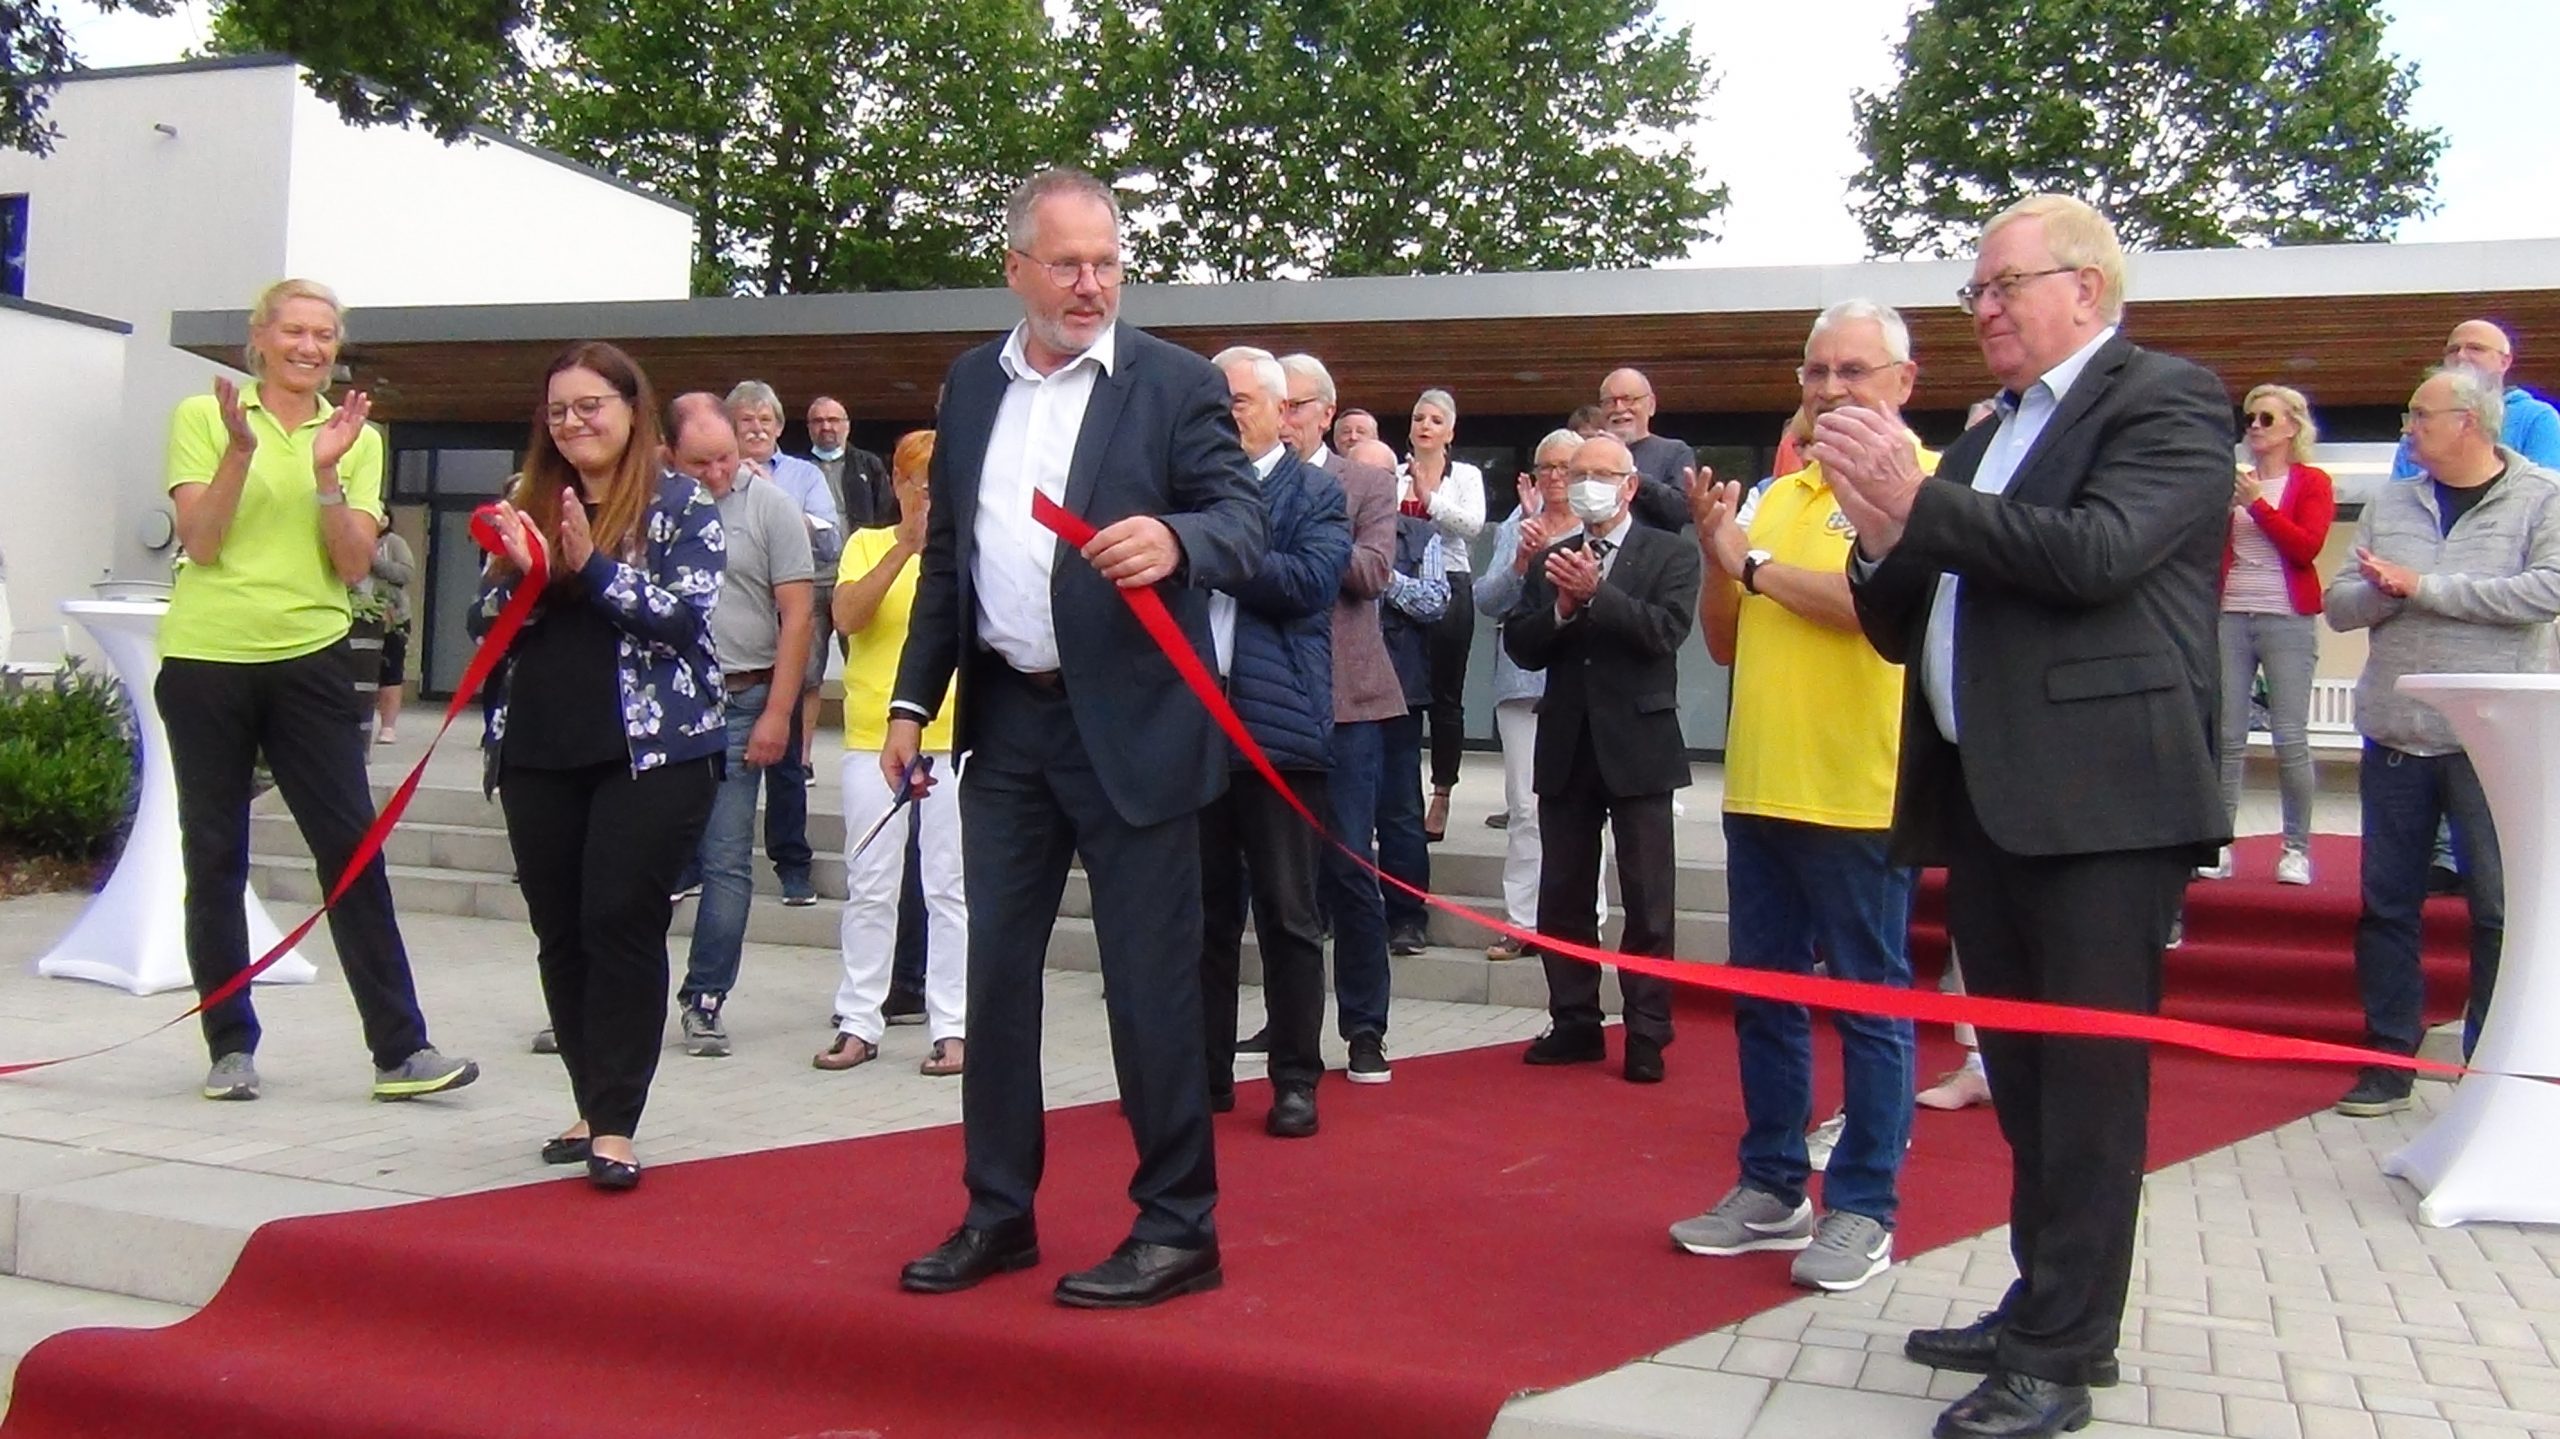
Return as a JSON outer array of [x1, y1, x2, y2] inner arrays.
[[1912, 835, 2470, 1045]]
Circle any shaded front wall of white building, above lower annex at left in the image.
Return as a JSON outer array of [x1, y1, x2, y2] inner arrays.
[[0, 64, 297, 578]]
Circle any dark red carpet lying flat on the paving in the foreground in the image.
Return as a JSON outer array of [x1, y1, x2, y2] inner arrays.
[[0, 1019, 2342, 1439]]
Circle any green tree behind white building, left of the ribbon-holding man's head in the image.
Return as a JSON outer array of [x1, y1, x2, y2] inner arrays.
[[527, 0, 1065, 294]]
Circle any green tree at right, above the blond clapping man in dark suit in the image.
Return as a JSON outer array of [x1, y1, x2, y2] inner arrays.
[[1851, 0, 2445, 256]]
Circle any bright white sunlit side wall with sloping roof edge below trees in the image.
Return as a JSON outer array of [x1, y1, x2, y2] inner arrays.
[[284, 84, 694, 304]]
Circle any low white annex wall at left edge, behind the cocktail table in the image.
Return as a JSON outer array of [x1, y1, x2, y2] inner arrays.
[[0, 305, 131, 661]]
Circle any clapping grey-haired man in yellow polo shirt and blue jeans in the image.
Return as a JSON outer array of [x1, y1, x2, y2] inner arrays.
[[1672, 300, 1938, 1290]]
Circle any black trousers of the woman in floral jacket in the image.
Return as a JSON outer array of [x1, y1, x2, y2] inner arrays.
[[499, 755, 719, 1137]]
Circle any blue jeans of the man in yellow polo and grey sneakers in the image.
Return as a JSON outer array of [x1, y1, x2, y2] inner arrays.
[[1725, 814, 1912, 1213]]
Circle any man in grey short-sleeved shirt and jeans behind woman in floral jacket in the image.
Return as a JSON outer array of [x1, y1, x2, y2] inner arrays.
[[668, 394, 817, 1057]]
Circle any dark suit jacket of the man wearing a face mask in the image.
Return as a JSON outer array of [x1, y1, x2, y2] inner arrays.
[[1503, 520, 1700, 799]]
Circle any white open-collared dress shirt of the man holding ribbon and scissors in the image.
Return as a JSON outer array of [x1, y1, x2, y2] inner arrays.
[[970, 325, 1119, 673]]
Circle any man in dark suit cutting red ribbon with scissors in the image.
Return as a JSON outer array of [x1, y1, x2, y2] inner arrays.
[[881, 169, 1265, 1308]]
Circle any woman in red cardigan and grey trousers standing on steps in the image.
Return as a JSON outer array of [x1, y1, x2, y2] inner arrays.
[[2202, 384, 2337, 883]]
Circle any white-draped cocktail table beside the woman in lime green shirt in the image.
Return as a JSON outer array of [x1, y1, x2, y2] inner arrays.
[[36, 599, 317, 993]]
